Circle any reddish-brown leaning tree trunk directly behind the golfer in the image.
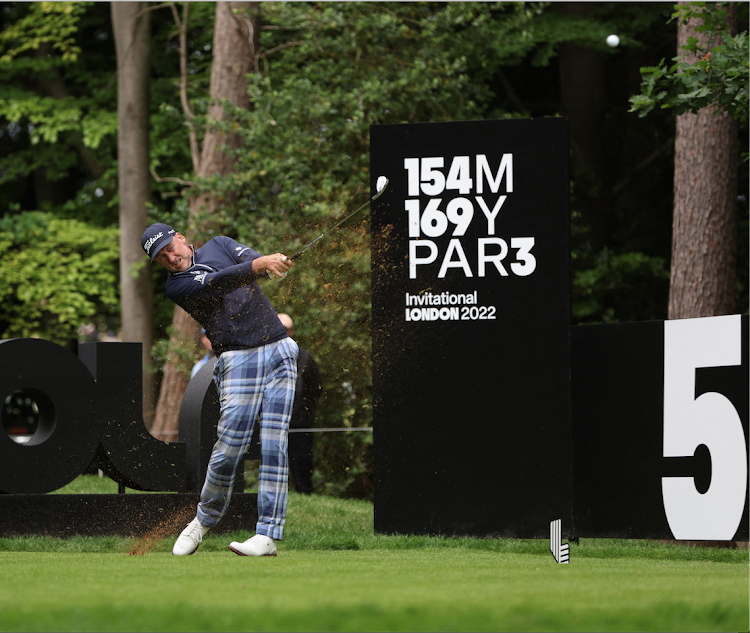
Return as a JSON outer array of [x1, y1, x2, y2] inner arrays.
[[151, 2, 260, 441]]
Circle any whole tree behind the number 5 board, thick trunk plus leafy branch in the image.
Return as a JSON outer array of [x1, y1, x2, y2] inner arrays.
[[632, 2, 748, 319]]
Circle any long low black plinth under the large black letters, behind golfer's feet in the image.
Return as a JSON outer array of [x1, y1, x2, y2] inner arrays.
[[0, 493, 258, 538]]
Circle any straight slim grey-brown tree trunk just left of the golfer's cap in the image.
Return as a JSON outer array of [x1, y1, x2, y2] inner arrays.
[[111, 2, 156, 426]]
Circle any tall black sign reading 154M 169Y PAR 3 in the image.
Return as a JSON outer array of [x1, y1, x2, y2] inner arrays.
[[371, 118, 571, 538]]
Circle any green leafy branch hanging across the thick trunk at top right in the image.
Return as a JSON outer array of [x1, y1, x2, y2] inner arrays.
[[630, 2, 750, 125]]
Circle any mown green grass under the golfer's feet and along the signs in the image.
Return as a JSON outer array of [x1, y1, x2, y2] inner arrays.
[[0, 478, 749, 631]]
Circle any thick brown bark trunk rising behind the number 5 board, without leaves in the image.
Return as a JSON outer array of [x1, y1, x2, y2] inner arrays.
[[669, 3, 739, 319]]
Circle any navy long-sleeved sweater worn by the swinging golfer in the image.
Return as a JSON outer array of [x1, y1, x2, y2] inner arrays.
[[167, 236, 287, 355]]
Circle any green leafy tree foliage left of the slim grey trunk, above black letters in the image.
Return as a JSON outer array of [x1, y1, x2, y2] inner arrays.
[[0, 2, 119, 350]]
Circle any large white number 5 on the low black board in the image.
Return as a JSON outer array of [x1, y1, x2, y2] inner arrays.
[[662, 315, 747, 540]]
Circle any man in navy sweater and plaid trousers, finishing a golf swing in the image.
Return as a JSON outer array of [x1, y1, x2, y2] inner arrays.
[[141, 223, 299, 556]]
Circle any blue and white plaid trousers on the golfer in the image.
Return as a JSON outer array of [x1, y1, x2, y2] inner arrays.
[[197, 338, 299, 540]]
